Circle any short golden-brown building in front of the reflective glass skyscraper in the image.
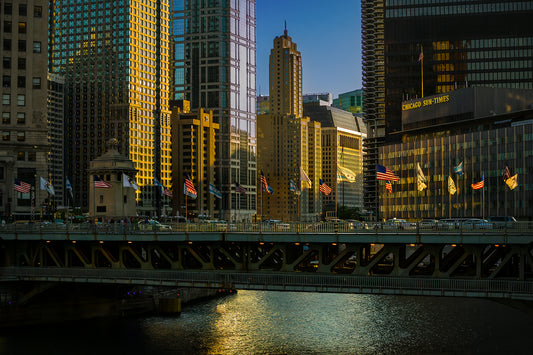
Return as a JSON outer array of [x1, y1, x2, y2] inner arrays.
[[171, 100, 220, 220]]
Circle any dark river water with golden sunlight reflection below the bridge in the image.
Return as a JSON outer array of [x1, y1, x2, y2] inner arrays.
[[0, 291, 533, 354]]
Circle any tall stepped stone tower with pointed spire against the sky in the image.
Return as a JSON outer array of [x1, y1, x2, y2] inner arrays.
[[257, 29, 322, 221]]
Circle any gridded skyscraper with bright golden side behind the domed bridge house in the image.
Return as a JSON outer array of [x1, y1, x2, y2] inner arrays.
[[50, 0, 171, 213]]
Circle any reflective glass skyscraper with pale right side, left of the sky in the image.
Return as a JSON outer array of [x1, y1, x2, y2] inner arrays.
[[172, 0, 257, 220]]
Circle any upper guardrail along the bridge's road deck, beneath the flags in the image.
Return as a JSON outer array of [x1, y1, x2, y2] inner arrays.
[[0, 222, 533, 237]]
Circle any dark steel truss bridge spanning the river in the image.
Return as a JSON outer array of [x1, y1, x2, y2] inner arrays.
[[0, 223, 533, 300]]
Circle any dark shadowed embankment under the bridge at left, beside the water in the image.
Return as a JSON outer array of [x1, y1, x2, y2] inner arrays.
[[0, 283, 234, 328]]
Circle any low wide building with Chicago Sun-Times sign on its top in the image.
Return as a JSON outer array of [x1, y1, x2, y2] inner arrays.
[[379, 87, 533, 220]]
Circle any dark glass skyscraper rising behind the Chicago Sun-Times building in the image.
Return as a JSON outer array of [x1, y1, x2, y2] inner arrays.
[[361, 0, 533, 220]]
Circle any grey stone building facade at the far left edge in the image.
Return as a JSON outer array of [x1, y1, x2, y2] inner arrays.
[[0, 0, 49, 219]]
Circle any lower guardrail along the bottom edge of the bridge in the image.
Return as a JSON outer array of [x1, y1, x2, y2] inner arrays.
[[4, 268, 533, 300]]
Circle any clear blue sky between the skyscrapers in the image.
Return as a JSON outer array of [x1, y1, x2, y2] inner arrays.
[[256, 0, 361, 98]]
